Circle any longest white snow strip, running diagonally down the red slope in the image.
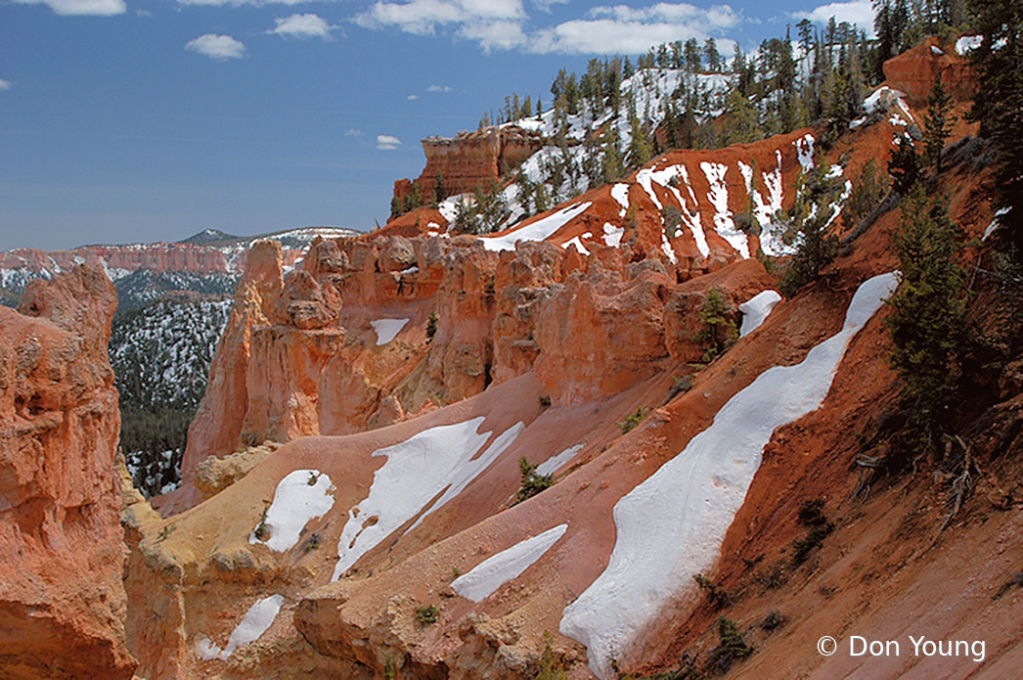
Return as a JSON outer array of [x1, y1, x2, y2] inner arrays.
[[561, 273, 898, 679]]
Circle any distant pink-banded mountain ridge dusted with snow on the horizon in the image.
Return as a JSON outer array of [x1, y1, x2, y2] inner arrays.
[[0, 227, 359, 312]]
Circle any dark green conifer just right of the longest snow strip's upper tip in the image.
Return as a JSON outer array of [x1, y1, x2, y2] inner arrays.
[[885, 184, 967, 450]]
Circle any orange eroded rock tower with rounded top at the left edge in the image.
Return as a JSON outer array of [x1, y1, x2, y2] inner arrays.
[[0, 266, 135, 678]]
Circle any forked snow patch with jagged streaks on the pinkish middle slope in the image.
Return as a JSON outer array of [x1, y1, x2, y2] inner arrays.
[[332, 416, 525, 581]]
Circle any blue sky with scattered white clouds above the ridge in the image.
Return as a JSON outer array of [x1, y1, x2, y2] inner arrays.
[[0, 0, 871, 250]]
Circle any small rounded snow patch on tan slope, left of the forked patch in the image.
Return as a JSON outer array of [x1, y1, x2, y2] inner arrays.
[[249, 469, 333, 552]]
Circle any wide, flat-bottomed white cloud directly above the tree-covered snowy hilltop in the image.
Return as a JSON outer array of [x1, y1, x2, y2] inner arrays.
[[526, 2, 745, 54]]
